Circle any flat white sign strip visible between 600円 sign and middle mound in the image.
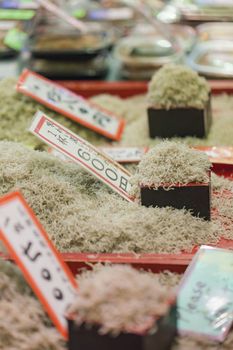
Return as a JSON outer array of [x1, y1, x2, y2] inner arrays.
[[100, 147, 148, 163]]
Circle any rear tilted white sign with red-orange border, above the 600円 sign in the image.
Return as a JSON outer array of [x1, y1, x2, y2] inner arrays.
[[16, 70, 125, 141]]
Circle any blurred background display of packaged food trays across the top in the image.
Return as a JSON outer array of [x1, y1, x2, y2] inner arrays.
[[0, 0, 233, 80]]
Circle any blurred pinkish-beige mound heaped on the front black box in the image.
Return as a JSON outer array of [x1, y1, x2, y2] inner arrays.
[[70, 265, 171, 334]]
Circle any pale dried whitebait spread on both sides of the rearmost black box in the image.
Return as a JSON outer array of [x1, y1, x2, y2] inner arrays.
[[92, 94, 233, 147]]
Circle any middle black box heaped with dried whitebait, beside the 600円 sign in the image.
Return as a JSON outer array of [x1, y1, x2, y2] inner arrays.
[[131, 140, 211, 220]]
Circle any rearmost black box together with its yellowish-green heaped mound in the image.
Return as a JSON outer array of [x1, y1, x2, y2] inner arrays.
[[147, 65, 212, 138]]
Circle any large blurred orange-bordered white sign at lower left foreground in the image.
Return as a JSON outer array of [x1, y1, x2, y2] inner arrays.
[[0, 192, 77, 338]]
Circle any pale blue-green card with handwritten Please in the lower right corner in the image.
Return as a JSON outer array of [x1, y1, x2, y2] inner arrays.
[[177, 246, 233, 342]]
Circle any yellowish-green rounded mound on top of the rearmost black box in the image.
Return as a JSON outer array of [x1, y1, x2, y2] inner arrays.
[[147, 64, 210, 109]]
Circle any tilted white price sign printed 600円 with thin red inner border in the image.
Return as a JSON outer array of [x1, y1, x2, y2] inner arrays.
[[29, 112, 133, 202]]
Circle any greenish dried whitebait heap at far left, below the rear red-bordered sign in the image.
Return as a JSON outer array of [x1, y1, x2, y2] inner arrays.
[[0, 78, 106, 149]]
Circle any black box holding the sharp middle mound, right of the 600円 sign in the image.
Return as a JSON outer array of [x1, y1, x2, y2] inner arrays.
[[141, 175, 211, 220]]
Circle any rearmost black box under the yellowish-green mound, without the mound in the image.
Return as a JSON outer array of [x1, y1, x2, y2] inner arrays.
[[147, 96, 212, 138]]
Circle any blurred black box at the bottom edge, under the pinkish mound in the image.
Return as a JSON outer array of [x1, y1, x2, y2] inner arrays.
[[68, 304, 177, 350]]
